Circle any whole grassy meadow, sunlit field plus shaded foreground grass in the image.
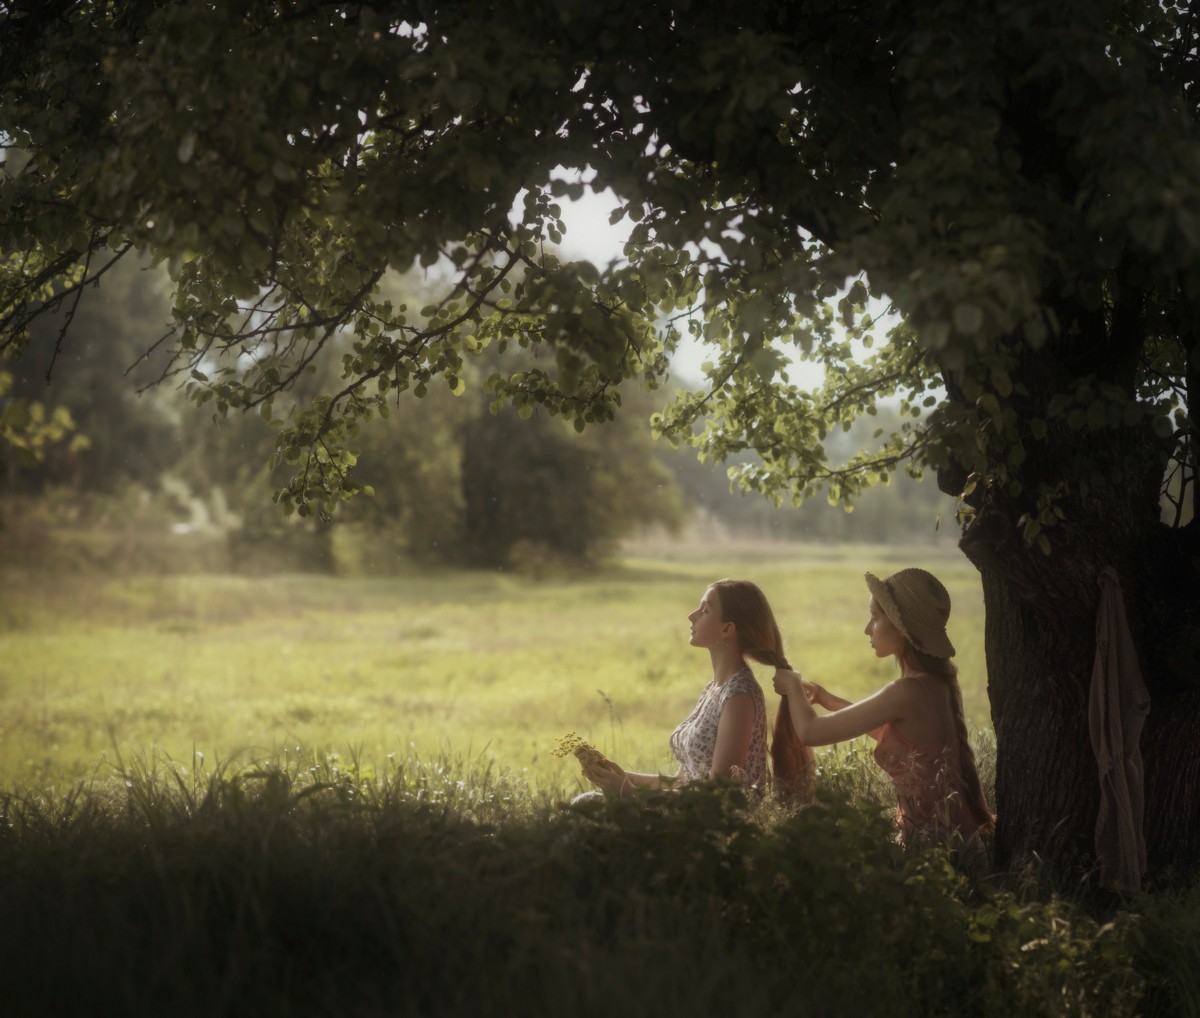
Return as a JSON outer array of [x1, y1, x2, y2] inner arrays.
[[0, 537, 1200, 1018]]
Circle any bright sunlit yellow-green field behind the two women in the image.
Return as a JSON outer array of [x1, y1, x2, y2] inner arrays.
[[0, 545, 990, 794]]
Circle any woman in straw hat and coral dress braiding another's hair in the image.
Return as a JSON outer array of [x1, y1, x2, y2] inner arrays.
[[775, 569, 994, 855]]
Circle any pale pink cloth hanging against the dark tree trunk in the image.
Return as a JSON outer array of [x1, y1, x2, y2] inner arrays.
[[1087, 567, 1150, 891]]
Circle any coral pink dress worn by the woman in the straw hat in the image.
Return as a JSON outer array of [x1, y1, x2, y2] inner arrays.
[[871, 721, 982, 845]]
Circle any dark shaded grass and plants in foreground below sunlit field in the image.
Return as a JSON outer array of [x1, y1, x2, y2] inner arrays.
[[0, 759, 1180, 1016]]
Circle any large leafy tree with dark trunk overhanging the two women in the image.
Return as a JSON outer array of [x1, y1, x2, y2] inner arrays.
[[0, 0, 1200, 868]]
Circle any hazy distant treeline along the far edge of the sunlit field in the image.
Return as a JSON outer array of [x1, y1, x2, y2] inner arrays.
[[0, 260, 954, 569]]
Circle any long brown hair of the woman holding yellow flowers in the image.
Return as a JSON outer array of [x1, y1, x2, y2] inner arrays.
[[712, 579, 816, 800]]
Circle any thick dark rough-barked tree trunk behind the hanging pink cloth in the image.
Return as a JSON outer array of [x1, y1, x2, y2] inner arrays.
[[961, 478, 1200, 879]]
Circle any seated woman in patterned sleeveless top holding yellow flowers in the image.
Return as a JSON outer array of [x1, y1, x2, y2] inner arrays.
[[573, 580, 812, 796]]
